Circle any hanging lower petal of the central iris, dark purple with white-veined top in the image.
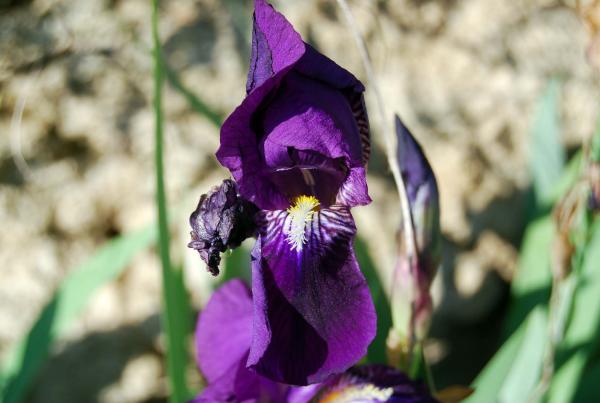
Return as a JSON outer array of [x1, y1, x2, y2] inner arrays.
[[248, 206, 376, 385]]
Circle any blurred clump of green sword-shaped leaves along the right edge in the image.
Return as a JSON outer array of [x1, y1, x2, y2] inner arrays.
[[468, 82, 600, 403]]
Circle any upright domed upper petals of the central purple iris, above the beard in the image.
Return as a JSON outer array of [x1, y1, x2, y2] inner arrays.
[[217, 0, 370, 210]]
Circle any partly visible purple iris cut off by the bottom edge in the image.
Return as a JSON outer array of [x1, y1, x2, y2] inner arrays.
[[194, 280, 435, 403]]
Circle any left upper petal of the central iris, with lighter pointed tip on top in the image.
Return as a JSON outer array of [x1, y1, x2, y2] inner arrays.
[[217, 0, 305, 209]]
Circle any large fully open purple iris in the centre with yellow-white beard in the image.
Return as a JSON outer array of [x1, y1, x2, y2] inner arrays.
[[192, 0, 376, 385]]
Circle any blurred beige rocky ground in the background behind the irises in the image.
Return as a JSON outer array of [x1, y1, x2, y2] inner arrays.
[[0, 0, 599, 402]]
